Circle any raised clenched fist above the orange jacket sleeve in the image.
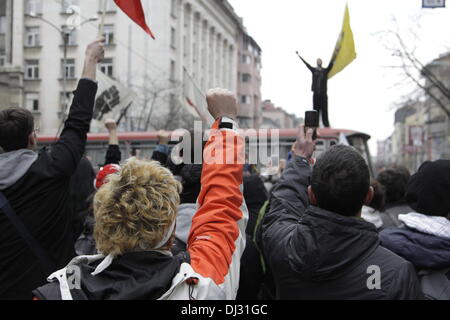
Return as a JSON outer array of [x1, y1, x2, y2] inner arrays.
[[206, 88, 237, 120]]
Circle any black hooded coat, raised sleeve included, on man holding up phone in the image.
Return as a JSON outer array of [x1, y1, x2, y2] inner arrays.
[[262, 157, 423, 299]]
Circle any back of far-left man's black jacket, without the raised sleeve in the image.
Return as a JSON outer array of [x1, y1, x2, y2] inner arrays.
[[0, 150, 75, 299]]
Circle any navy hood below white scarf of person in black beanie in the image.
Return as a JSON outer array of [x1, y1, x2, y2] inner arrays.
[[380, 227, 450, 269]]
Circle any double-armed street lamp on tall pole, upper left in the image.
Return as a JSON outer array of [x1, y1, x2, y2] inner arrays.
[[25, 10, 98, 133]]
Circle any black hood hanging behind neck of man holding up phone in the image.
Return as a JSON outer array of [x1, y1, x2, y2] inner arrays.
[[288, 207, 379, 281]]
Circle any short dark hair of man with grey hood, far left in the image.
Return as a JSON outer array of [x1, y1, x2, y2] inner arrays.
[[0, 108, 34, 152]]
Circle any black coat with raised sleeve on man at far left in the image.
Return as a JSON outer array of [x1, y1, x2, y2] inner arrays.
[[0, 80, 97, 299]]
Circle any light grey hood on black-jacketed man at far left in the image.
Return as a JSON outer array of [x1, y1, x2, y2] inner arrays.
[[0, 149, 38, 190]]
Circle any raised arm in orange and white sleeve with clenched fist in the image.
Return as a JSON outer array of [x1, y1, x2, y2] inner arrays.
[[188, 89, 248, 299]]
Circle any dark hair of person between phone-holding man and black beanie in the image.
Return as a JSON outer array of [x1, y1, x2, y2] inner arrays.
[[377, 167, 410, 204]]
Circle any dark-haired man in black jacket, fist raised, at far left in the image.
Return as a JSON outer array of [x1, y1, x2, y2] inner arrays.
[[0, 38, 104, 299]]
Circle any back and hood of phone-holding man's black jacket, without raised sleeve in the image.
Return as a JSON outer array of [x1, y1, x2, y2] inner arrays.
[[266, 207, 421, 300]]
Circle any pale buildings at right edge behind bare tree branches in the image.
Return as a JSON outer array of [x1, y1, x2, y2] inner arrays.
[[377, 54, 450, 172]]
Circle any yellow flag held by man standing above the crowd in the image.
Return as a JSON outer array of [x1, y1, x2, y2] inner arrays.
[[328, 5, 356, 79]]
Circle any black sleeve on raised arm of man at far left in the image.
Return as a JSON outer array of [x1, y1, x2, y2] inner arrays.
[[48, 79, 97, 177]]
